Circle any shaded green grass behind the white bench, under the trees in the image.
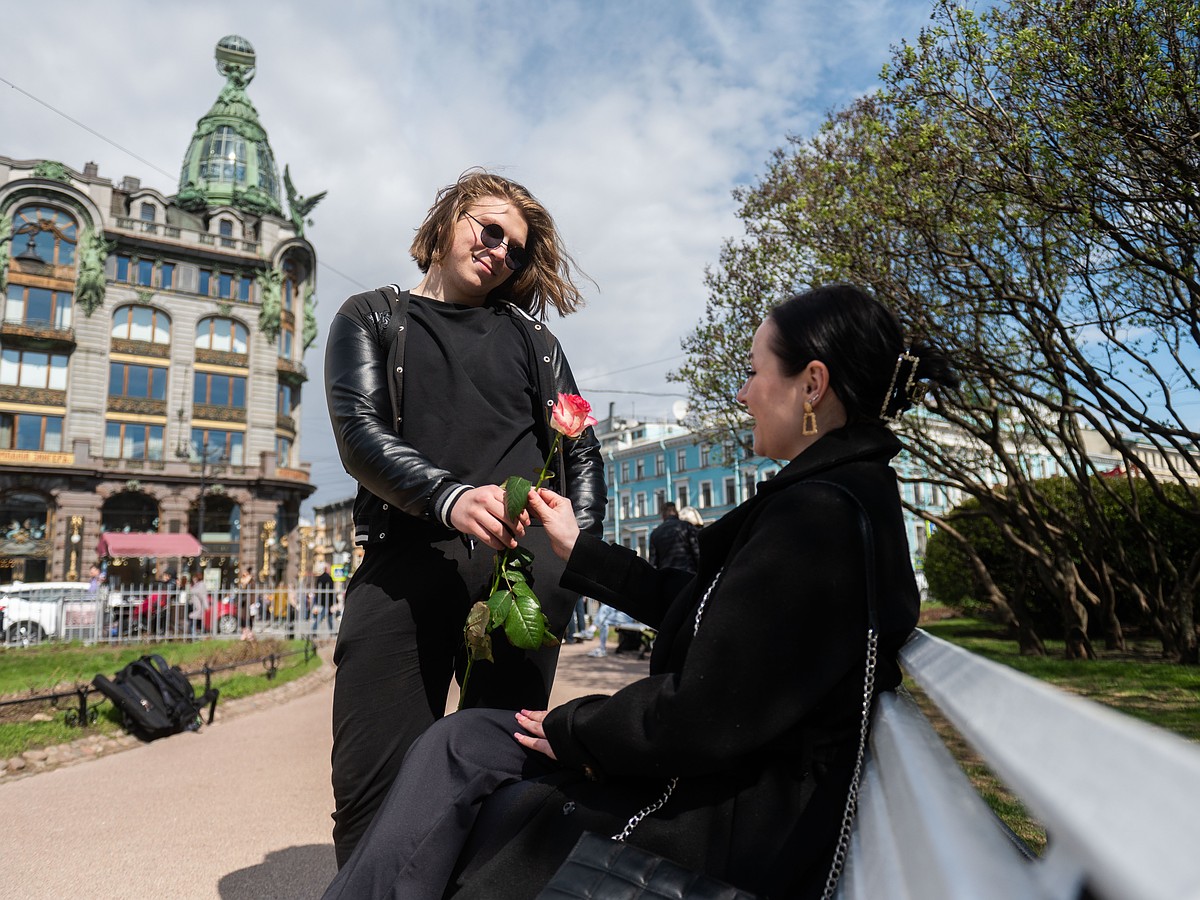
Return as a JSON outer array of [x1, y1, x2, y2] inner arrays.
[[905, 618, 1200, 853]]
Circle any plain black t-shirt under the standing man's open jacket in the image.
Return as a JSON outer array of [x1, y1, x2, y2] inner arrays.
[[402, 294, 548, 494]]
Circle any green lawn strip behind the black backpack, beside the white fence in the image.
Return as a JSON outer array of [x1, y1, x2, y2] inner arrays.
[[0, 641, 322, 758]]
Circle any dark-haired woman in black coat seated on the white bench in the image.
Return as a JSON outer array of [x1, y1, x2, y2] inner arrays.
[[326, 286, 955, 900]]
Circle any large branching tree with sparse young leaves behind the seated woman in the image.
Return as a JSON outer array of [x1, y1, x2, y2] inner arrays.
[[679, 0, 1200, 662]]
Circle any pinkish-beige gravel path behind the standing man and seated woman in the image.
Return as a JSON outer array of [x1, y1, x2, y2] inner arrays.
[[0, 642, 648, 900]]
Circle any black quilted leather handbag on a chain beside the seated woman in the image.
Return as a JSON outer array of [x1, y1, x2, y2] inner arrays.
[[538, 832, 755, 900]]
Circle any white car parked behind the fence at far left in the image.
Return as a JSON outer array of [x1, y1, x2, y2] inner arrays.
[[0, 581, 96, 644]]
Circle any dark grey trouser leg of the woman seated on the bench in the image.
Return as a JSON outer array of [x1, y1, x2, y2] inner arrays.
[[324, 710, 556, 900]]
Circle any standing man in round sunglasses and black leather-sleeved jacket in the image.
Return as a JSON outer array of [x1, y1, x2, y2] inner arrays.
[[325, 170, 606, 864]]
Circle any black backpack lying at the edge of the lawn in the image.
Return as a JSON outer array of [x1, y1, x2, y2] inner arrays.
[[92, 654, 220, 740]]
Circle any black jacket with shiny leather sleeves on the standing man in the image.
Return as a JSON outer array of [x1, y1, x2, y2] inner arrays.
[[325, 290, 607, 544]]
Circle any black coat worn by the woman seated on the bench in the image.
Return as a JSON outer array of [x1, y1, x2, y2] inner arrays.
[[456, 425, 919, 898]]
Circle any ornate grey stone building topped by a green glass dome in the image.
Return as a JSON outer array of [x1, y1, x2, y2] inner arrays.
[[0, 35, 320, 584]]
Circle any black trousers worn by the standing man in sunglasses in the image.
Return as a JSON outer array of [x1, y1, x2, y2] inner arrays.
[[331, 528, 576, 866]]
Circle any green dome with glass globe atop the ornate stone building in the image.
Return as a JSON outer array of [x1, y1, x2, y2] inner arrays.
[[175, 35, 282, 216]]
